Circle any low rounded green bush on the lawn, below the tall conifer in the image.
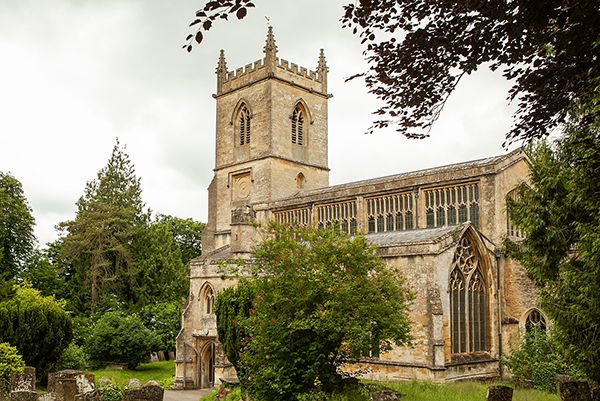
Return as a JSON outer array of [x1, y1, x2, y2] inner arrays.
[[85, 311, 159, 369]]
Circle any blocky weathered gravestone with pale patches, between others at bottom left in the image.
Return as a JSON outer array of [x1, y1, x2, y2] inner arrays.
[[48, 370, 100, 401]]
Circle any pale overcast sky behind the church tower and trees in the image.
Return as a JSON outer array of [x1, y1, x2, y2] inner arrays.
[[0, 0, 513, 245]]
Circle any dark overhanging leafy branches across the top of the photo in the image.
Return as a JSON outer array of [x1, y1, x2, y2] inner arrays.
[[184, 0, 600, 142]]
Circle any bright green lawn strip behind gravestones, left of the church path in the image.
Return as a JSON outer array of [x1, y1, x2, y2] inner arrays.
[[91, 361, 175, 388]]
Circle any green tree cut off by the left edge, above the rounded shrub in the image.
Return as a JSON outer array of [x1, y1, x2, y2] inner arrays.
[[0, 171, 36, 286]]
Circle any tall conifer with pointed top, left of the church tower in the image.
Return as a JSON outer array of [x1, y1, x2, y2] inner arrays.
[[59, 141, 149, 313]]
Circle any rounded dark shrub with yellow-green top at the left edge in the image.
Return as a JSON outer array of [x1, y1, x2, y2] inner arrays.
[[0, 287, 72, 378]]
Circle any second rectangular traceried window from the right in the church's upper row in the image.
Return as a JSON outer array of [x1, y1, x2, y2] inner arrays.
[[367, 192, 414, 233]]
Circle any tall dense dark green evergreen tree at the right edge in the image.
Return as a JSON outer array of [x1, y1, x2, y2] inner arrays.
[[508, 108, 600, 382]]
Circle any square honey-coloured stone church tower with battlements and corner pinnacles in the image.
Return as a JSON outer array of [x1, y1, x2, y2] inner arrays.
[[203, 27, 330, 253]]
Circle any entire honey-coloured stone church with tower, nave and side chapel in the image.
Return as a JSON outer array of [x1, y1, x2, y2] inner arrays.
[[175, 28, 546, 388]]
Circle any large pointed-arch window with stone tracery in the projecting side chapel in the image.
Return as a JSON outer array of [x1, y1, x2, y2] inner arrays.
[[449, 237, 489, 354]]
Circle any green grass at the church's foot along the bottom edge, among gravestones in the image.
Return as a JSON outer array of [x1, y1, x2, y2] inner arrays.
[[201, 381, 560, 401]]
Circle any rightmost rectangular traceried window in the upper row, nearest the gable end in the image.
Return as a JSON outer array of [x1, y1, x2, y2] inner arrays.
[[425, 184, 479, 228]]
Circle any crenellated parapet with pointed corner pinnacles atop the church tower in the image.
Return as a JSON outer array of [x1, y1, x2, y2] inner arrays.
[[216, 27, 328, 96]]
